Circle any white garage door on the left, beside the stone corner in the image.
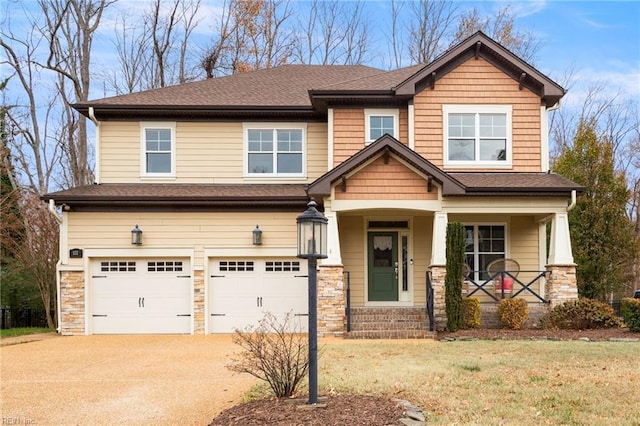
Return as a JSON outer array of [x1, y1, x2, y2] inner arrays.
[[91, 259, 191, 334]]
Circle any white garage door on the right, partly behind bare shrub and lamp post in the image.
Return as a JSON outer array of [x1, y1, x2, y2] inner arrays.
[[209, 258, 308, 333]]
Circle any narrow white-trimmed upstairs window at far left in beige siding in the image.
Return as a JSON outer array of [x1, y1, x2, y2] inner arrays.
[[140, 123, 176, 177]]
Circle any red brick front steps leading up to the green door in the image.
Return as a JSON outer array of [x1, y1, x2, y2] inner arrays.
[[345, 307, 434, 339]]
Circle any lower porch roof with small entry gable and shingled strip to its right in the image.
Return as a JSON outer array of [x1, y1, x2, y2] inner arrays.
[[307, 134, 584, 199]]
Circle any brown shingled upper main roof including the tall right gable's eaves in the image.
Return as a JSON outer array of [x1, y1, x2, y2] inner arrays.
[[73, 32, 565, 120]]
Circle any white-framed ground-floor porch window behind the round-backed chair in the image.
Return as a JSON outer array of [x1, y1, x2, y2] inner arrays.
[[464, 225, 506, 280]]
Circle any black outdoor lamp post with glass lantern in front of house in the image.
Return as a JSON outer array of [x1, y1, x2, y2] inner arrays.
[[296, 200, 329, 404]]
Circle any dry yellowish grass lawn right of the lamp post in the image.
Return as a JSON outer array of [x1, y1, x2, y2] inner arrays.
[[266, 339, 640, 425]]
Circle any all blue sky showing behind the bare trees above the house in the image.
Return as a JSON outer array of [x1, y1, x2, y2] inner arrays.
[[0, 0, 640, 106]]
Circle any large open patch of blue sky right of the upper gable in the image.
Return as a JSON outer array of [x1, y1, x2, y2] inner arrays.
[[500, 0, 640, 102]]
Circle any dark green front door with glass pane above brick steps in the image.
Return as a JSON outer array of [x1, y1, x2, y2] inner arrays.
[[367, 232, 398, 302]]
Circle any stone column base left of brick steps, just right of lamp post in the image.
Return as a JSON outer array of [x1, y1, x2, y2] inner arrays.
[[318, 265, 346, 336]]
